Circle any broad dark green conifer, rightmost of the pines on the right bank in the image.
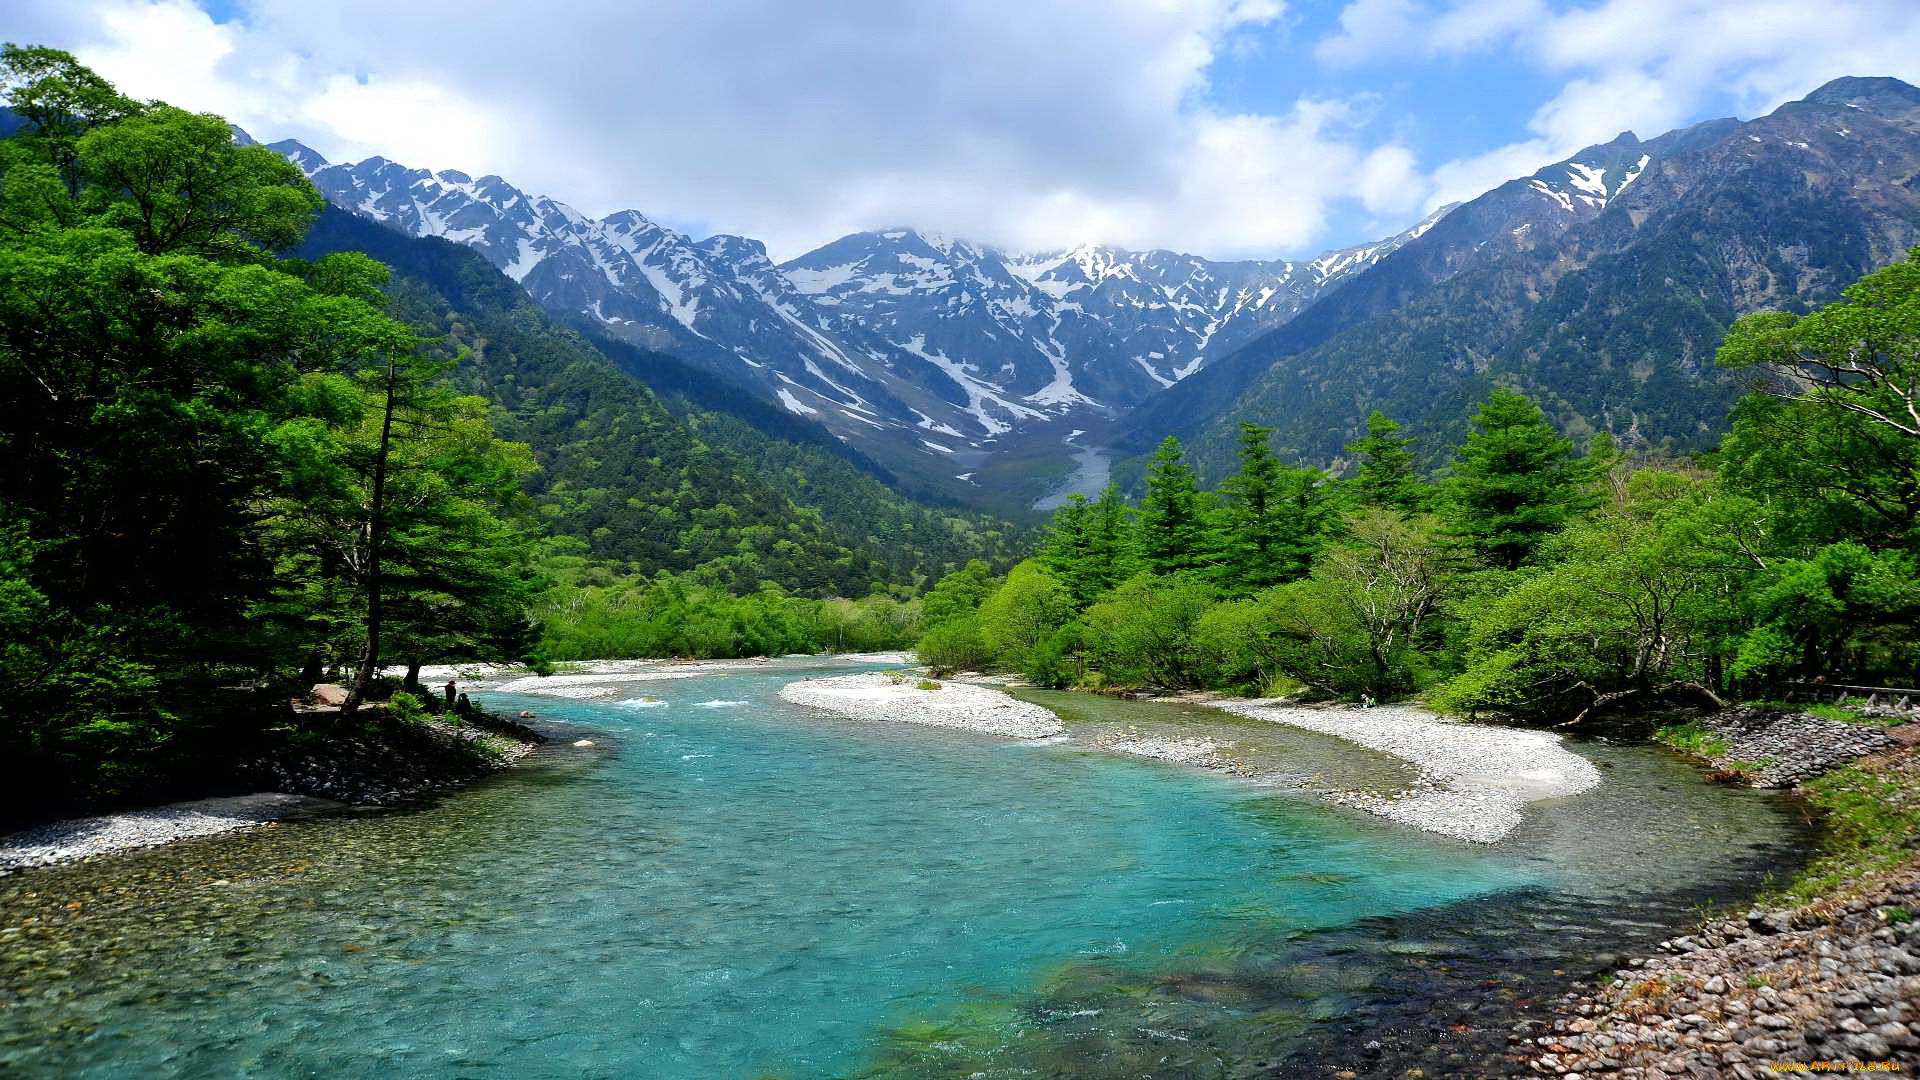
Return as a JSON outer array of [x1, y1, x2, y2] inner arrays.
[[1448, 390, 1594, 569]]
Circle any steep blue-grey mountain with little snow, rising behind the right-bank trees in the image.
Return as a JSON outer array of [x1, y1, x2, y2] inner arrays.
[[1119, 79, 1920, 475]]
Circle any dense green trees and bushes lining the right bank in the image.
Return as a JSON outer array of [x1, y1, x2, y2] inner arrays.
[[920, 252, 1920, 721]]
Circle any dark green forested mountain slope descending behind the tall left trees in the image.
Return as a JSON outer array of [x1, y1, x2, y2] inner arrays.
[[300, 208, 1020, 596]]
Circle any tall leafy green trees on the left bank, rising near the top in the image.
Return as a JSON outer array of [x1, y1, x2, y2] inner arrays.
[[0, 46, 552, 813]]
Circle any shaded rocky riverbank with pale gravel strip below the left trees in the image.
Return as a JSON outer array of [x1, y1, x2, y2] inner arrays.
[[0, 717, 541, 876]]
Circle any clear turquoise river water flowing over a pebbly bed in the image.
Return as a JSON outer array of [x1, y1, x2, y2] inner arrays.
[[0, 665, 1791, 1078]]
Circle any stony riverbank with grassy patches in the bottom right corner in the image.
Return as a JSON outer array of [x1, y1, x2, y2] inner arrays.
[[1517, 709, 1920, 1080]]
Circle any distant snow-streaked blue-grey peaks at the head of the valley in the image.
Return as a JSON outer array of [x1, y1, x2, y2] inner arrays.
[[273, 140, 1438, 488]]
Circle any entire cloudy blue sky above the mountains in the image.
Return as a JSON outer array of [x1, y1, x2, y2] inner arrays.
[[11, 0, 1920, 258]]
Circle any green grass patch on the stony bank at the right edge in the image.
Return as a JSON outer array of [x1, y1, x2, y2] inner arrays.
[[1768, 751, 1920, 905]]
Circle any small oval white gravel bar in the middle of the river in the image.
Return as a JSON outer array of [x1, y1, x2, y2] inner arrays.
[[780, 673, 1066, 738]]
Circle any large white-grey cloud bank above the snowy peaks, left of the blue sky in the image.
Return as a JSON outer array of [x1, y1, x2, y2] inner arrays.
[[11, 0, 1428, 256]]
